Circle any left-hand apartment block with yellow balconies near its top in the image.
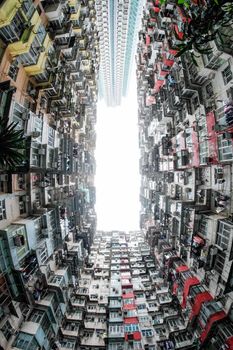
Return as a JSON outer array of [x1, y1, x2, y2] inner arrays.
[[0, 0, 99, 350]]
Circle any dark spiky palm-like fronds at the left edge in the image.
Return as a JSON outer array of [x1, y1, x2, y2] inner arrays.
[[0, 120, 25, 168]]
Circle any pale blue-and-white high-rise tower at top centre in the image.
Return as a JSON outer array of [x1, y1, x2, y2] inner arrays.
[[96, 0, 144, 106]]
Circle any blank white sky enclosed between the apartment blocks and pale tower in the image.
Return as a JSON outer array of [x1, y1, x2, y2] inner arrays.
[[95, 71, 140, 231]]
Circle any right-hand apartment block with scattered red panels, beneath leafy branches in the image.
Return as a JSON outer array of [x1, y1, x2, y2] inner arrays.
[[136, 1, 233, 349]]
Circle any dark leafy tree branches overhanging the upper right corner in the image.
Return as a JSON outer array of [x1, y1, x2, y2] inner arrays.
[[160, 0, 233, 57]]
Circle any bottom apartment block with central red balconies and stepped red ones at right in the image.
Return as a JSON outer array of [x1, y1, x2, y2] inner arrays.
[[77, 231, 233, 350]]
